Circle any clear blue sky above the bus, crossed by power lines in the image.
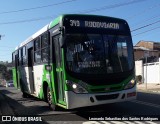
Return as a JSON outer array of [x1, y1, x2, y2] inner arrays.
[[0, 0, 160, 62]]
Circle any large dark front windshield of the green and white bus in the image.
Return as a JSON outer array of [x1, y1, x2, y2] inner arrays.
[[65, 34, 134, 74]]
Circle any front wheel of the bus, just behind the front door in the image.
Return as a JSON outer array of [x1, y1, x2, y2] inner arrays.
[[47, 87, 57, 111]]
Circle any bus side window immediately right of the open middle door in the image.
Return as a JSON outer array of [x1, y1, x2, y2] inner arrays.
[[34, 37, 41, 63]]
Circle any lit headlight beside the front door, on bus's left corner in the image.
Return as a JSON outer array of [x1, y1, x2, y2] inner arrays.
[[66, 80, 88, 93]]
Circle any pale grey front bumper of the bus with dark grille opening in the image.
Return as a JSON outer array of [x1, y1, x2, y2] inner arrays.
[[65, 86, 136, 109]]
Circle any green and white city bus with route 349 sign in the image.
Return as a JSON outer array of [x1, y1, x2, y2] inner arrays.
[[12, 14, 137, 110]]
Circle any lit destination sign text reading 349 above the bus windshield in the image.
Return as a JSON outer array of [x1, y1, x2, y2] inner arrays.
[[70, 20, 120, 29]]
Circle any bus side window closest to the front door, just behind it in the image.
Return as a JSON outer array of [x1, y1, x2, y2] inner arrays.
[[41, 32, 50, 62]]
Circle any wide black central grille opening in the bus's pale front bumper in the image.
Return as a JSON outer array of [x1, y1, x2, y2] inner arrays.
[[95, 93, 119, 101]]
